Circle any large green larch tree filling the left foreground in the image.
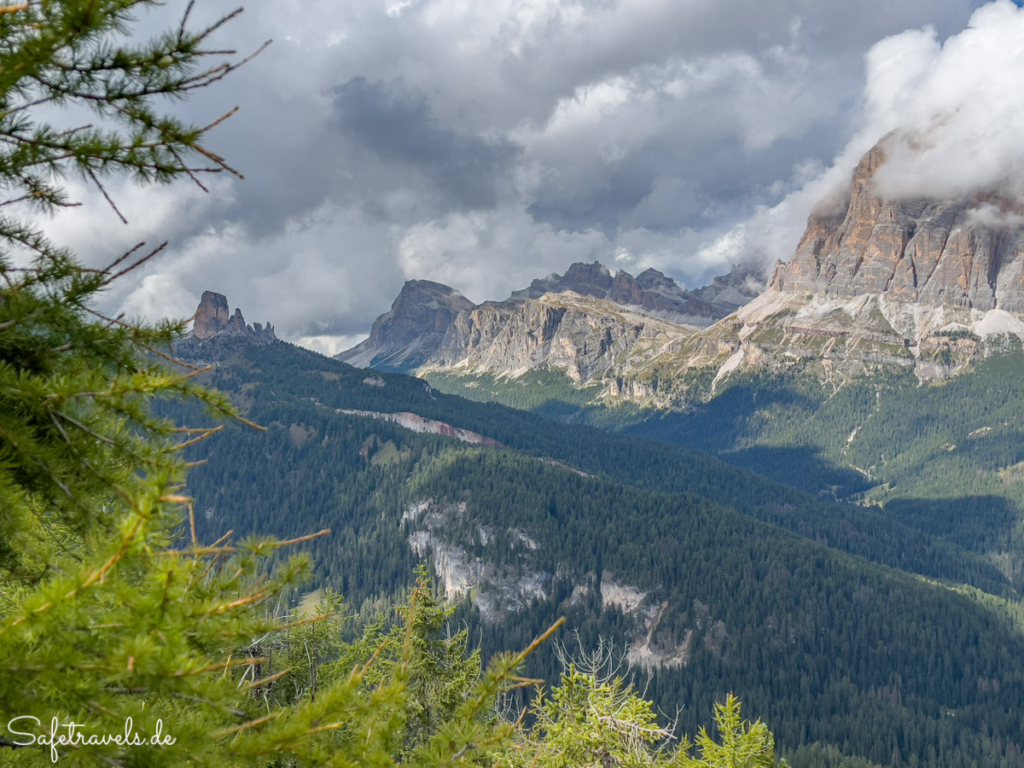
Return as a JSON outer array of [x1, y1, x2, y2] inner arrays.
[[0, 0, 540, 767]]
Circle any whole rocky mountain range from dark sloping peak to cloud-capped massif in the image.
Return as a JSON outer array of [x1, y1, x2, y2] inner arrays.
[[338, 134, 1024, 407]]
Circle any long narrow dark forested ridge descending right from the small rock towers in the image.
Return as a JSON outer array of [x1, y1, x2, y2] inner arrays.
[[182, 338, 1010, 594]]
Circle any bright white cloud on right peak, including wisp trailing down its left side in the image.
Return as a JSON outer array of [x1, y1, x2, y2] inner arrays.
[[706, 0, 1024, 274]]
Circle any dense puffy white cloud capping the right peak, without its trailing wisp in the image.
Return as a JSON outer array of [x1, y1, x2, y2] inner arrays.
[[865, 0, 1024, 197]]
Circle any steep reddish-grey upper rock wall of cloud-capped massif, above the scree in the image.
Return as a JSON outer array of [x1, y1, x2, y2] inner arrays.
[[771, 136, 1024, 313]]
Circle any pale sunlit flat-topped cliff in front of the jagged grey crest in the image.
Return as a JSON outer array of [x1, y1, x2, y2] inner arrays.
[[421, 292, 694, 391]]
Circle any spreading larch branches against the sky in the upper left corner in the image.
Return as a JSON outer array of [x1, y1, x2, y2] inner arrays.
[[0, 0, 253, 204]]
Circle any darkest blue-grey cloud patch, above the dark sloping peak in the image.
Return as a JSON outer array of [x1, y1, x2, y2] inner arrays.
[[331, 77, 521, 210]]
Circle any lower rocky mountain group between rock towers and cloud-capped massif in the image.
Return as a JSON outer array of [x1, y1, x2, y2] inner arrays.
[[338, 262, 764, 385]]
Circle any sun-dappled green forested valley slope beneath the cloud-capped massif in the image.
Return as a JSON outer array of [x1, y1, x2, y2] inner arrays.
[[428, 341, 1024, 585]]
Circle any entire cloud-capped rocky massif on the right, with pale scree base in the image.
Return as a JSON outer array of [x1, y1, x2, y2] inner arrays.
[[622, 135, 1024, 406]]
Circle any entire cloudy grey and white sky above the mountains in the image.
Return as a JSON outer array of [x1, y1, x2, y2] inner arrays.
[[39, 0, 1024, 353]]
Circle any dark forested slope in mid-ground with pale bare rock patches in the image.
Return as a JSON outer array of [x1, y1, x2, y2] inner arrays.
[[169, 339, 1024, 766]]
